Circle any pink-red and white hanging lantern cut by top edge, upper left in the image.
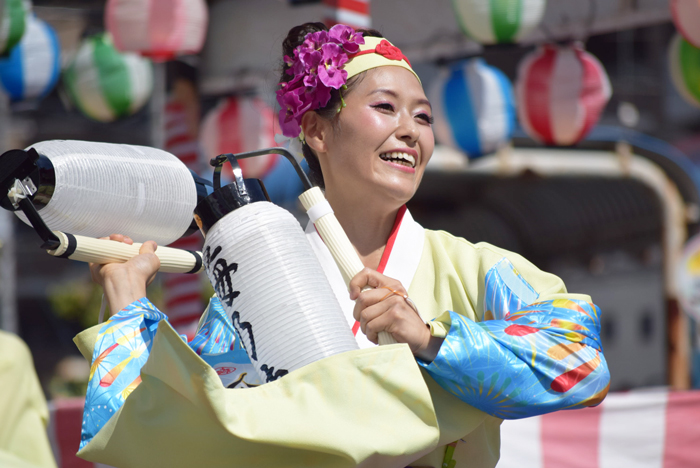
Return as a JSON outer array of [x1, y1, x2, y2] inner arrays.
[[105, 0, 208, 61]]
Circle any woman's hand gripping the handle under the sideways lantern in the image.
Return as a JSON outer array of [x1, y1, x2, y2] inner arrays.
[[90, 234, 160, 315]]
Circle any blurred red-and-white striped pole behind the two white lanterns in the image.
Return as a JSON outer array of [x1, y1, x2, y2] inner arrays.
[[163, 99, 202, 339]]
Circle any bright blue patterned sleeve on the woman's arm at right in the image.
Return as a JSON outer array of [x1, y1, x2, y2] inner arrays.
[[419, 258, 610, 419]]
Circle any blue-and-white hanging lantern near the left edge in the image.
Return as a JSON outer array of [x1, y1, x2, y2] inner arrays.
[[0, 16, 61, 102]]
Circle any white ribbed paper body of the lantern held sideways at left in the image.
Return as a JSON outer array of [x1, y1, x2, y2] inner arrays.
[[15, 140, 197, 245]]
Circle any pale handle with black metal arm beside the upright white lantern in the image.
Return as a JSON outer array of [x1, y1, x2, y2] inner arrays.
[[227, 148, 396, 345]]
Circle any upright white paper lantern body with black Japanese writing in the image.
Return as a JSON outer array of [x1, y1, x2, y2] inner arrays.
[[202, 202, 358, 382]]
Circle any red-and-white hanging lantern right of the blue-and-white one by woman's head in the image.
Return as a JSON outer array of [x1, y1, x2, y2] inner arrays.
[[515, 44, 612, 146]]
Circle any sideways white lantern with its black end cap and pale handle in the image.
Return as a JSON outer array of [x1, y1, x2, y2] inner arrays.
[[0, 140, 211, 273]]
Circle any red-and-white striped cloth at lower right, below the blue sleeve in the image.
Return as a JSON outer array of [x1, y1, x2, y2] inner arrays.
[[497, 390, 700, 468]]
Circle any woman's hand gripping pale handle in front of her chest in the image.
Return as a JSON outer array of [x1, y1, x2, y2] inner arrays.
[[350, 268, 443, 362]]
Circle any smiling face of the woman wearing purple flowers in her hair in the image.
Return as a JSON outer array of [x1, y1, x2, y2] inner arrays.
[[319, 66, 435, 209]]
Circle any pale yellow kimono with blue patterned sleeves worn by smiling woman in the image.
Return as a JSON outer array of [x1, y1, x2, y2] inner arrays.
[[76, 207, 608, 468]]
